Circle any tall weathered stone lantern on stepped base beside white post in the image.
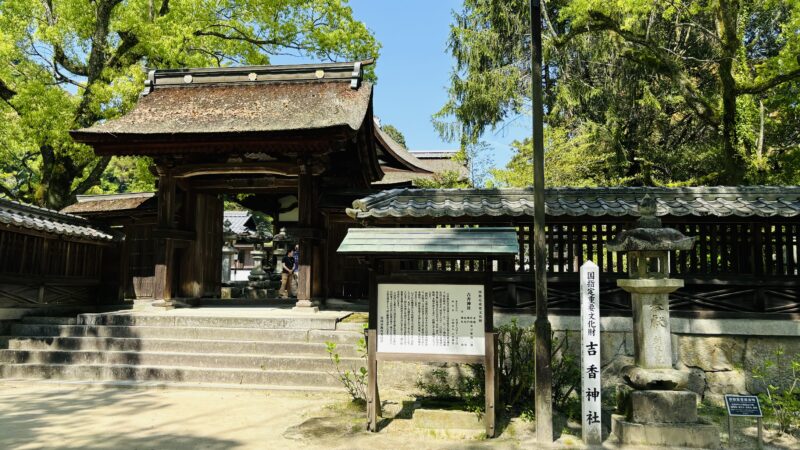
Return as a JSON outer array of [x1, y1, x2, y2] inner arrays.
[[607, 195, 719, 448]]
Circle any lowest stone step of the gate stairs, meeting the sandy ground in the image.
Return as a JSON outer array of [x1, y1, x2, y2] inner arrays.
[[0, 364, 341, 387]]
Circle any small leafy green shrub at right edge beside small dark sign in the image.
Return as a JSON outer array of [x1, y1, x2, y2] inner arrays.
[[753, 348, 800, 433]]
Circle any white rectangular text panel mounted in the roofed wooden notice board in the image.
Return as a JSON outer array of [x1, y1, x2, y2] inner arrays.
[[377, 283, 486, 356]]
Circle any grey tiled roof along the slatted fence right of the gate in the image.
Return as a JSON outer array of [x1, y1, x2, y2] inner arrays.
[[347, 186, 800, 219]]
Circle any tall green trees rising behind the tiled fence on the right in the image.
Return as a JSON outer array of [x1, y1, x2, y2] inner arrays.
[[434, 0, 800, 185]]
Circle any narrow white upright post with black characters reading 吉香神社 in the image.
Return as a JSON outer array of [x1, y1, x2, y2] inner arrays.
[[581, 261, 603, 445]]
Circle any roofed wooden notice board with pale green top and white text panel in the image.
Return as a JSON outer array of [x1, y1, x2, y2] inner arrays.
[[338, 227, 519, 437]]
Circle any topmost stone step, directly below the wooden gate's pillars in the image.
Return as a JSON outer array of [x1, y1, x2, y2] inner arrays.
[[78, 313, 344, 330]]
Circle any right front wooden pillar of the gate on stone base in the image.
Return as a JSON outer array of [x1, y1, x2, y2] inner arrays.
[[294, 164, 318, 311]]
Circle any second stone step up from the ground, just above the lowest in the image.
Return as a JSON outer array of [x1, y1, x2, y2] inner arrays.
[[0, 350, 365, 373]]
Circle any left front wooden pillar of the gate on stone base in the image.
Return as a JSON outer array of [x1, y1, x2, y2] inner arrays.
[[153, 167, 176, 308]]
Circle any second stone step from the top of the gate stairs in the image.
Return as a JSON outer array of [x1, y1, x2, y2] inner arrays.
[[10, 323, 363, 345]]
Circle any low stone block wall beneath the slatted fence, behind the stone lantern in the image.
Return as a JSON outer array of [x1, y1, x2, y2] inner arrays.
[[379, 313, 800, 404]]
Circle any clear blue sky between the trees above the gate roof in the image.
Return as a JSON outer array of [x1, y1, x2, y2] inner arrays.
[[350, 0, 531, 167]]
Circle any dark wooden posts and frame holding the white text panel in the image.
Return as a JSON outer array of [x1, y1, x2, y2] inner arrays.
[[366, 268, 499, 437]]
